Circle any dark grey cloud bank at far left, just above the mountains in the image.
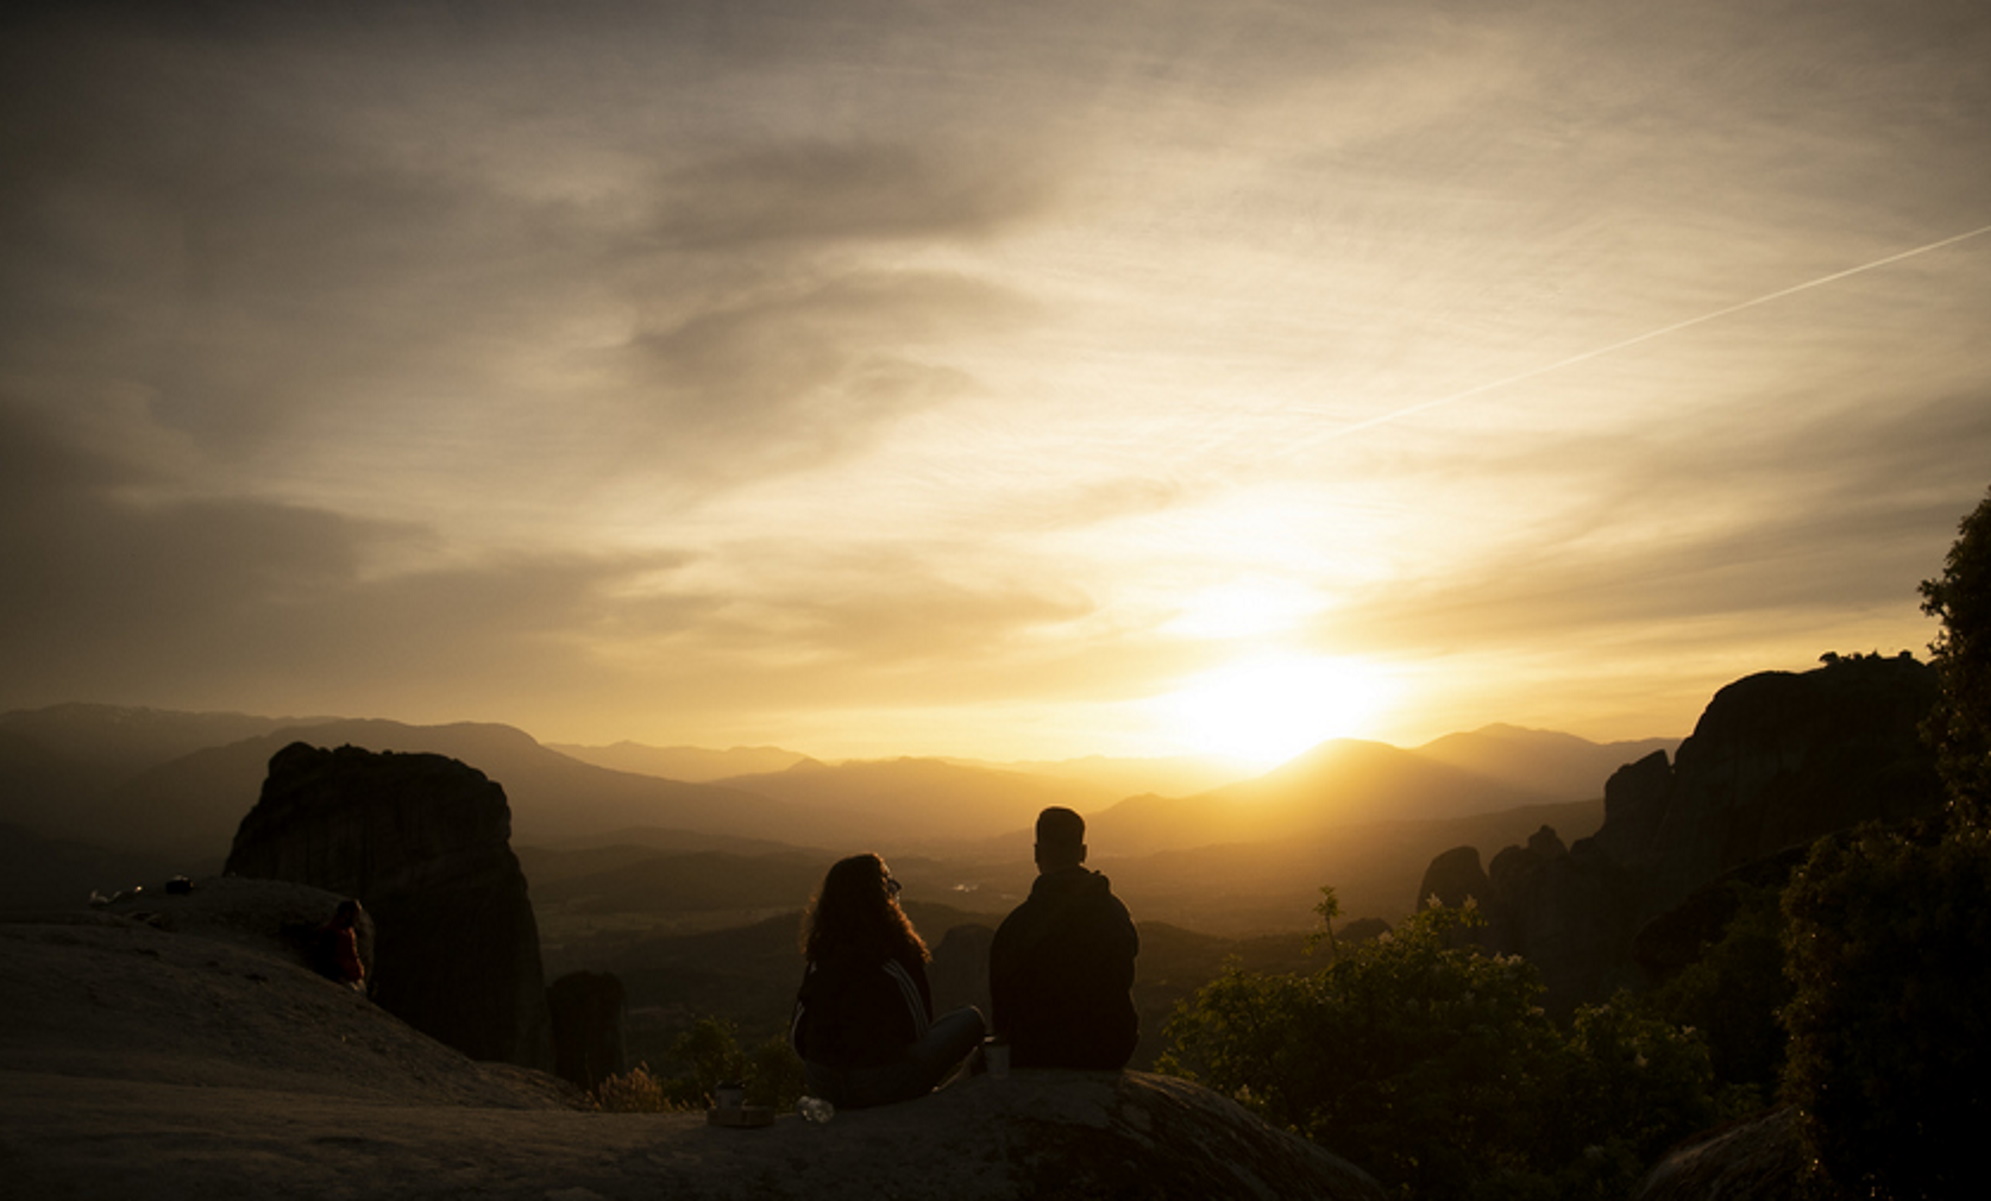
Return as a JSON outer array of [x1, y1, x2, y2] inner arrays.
[[0, 406, 701, 703]]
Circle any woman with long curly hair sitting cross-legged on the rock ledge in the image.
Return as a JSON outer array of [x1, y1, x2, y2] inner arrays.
[[788, 854, 984, 1109]]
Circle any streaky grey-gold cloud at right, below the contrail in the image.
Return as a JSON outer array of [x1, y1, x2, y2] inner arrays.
[[1332, 394, 1991, 649]]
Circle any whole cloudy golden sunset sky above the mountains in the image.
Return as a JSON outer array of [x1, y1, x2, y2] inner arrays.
[[0, 0, 1991, 761]]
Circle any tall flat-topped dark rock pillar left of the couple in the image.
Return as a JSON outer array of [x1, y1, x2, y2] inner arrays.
[[227, 743, 552, 1068]]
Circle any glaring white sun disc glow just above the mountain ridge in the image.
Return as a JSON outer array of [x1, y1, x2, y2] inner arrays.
[[1161, 655, 1396, 767]]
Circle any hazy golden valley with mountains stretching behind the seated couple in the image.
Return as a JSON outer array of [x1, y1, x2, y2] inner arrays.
[[0, 705, 1676, 1066]]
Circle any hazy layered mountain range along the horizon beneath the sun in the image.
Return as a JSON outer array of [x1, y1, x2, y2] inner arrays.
[[0, 705, 1674, 928]]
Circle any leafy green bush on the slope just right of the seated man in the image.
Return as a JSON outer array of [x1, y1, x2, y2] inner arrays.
[[1159, 908, 1714, 1199]]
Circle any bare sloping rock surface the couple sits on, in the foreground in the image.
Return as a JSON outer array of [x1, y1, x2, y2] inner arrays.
[[0, 880, 1382, 1201]]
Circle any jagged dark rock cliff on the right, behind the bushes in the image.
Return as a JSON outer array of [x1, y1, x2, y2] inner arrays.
[[1422, 655, 1943, 1012]]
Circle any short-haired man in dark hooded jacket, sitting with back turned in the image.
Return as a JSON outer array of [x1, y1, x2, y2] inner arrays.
[[990, 809, 1141, 1072]]
